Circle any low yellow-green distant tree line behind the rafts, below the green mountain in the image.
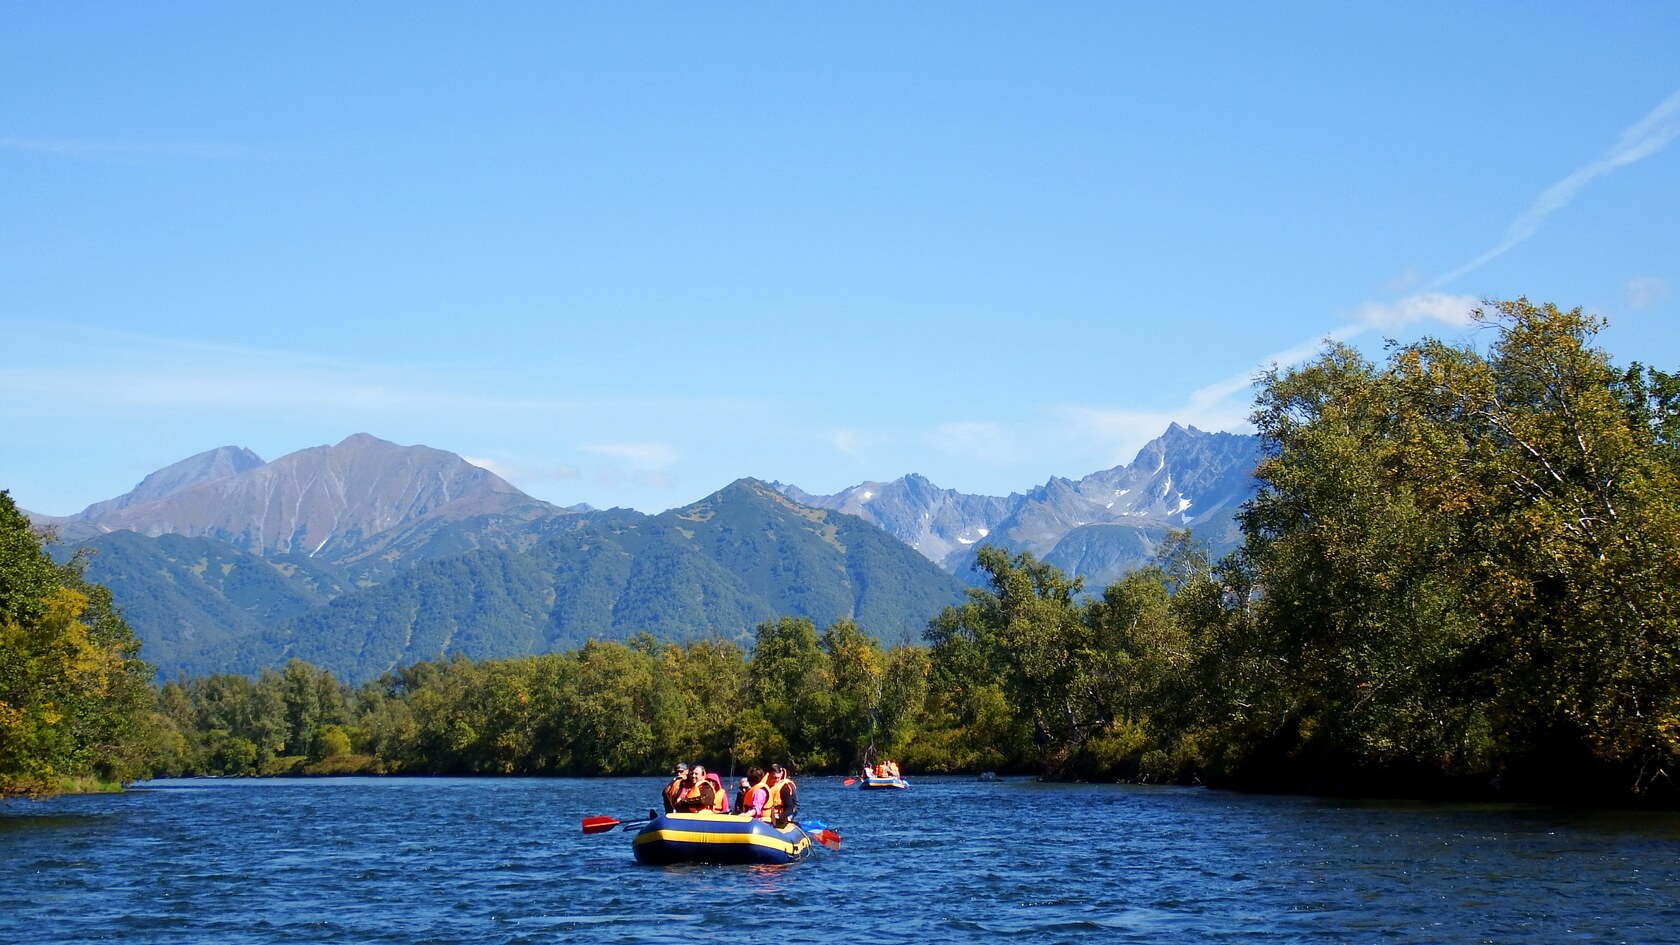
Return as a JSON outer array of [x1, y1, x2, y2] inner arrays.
[[155, 617, 947, 775]]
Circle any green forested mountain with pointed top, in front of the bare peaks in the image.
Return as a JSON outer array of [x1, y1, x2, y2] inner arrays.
[[163, 479, 963, 683]]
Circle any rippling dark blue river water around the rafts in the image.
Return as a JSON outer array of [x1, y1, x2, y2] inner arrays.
[[0, 777, 1680, 945]]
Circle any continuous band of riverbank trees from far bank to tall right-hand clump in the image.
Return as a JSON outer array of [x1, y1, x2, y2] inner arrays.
[[6, 299, 1680, 805]]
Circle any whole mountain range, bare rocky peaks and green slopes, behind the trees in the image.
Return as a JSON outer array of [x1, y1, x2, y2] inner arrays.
[[30, 425, 1258, 681]]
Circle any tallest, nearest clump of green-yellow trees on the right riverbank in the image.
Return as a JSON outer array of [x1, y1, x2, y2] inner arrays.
[[1209, 299, 1680, 792]]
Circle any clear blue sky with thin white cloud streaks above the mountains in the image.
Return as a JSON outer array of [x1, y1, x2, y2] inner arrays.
[[0, 2, 1680, 515]]
